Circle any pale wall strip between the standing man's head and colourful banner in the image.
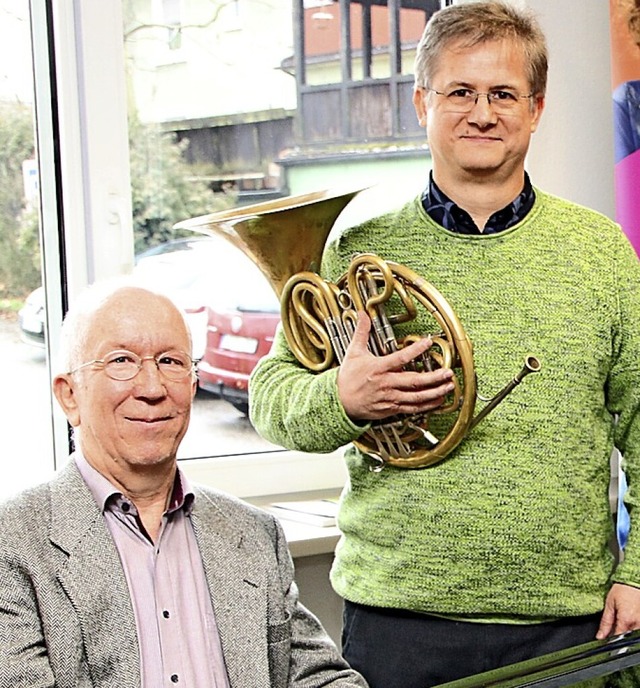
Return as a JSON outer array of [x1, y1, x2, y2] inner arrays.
[[526, 0, 615, 218]]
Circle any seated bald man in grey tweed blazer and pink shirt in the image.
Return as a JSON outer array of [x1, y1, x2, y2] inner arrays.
[[0, 285, 366, 688]]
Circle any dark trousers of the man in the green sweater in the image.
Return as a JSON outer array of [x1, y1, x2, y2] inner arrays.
[[342, 601, 601, 688]]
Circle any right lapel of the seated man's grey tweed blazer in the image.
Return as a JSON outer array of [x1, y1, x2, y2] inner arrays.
[[192, 490, 269, 688]]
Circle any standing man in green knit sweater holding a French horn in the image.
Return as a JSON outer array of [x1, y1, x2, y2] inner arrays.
[[250, 2, 640, 688]]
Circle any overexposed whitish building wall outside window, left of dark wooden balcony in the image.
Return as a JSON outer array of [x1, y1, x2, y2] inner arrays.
[[126, 0, 296, 122]]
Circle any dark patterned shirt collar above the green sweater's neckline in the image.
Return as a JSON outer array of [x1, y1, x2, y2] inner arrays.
[[421, 172, 536, 235]]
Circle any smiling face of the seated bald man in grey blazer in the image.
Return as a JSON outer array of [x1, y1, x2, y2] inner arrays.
[[54, 288, 195, 483]]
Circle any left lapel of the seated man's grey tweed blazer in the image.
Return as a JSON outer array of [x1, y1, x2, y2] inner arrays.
[[50, 462, 140, 688]]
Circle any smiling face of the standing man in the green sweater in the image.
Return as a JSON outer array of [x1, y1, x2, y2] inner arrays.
[[414, 40, 544, 192]]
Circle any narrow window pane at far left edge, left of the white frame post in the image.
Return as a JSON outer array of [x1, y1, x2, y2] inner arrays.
[[0, 0, 54, 497]]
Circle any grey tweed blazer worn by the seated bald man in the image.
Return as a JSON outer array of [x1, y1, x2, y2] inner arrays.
[[0, 461, 366, 688]]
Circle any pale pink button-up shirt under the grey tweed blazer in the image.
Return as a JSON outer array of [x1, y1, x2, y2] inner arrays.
[[76, 453, 229, 688]]
